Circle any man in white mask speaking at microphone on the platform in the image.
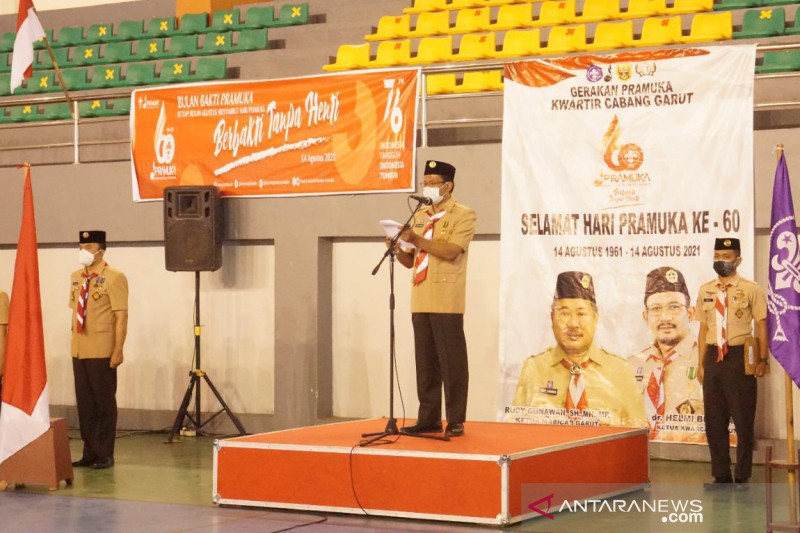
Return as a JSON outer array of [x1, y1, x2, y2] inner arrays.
[[397, 161, 476, 437]]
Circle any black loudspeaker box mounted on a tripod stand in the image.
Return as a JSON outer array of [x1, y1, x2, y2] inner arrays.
[[164, 186, 223, 272]]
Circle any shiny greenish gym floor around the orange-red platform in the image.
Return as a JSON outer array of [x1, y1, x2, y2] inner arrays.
[[0, 432, 788, 533]]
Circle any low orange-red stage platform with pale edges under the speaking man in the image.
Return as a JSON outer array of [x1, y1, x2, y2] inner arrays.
[[214, 419, 649, 525]]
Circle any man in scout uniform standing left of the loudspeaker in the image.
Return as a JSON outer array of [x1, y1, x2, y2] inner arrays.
[[69, 231, 128, 468]]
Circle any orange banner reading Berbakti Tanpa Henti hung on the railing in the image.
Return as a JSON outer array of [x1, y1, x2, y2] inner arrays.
[[131, 69, 419, 201]]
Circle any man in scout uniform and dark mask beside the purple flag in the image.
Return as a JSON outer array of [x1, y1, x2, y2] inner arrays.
[[697, 238, 769, 490]]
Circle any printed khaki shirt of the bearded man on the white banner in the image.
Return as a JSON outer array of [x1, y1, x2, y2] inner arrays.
[[628, 334, 705, 442]]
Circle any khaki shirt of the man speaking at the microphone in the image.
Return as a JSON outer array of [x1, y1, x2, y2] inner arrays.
[[411, 196, 477, 314]]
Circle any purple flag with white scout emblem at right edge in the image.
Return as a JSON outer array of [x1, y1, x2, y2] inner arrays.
[[767, 154, 800, 386]]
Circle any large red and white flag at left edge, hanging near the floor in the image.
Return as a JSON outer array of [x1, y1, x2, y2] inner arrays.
[[0, 165, 50, 463]]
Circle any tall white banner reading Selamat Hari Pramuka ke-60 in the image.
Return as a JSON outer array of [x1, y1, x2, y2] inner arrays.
[[499, 45, 755, 442]]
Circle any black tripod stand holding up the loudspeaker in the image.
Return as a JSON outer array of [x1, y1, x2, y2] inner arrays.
[[167, 271, 247, 443]]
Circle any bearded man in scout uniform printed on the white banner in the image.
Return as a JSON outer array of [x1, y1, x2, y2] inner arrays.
[[628, 266, 705, 442]]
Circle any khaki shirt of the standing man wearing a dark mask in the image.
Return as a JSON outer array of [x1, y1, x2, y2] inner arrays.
[[697, 274, 767, 349]]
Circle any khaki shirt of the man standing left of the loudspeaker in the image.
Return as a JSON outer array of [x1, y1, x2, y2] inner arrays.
[[69, 261, 128, 359]]
